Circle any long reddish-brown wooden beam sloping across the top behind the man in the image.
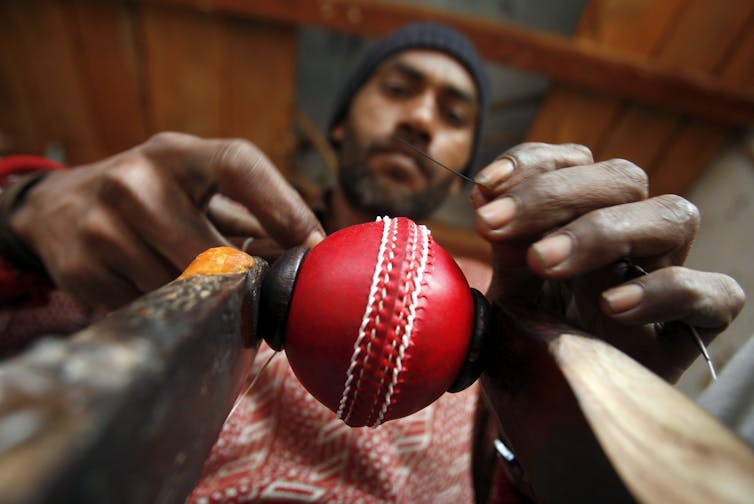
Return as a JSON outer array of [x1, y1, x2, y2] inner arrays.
[[143, 0, 754, 125]]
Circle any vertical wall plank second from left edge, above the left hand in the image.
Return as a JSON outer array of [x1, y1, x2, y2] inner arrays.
[[69, 0, 147, 154]]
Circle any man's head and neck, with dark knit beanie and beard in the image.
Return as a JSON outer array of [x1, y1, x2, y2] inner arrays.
[[314, 24, 489, 234]]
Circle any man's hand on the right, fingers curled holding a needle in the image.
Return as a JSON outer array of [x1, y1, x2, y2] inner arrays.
[[471, 143, 744, 380]]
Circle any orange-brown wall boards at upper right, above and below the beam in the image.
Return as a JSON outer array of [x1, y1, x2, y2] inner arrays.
[[529, 0, 754, 194]]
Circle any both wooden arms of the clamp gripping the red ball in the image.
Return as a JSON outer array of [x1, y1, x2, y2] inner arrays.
[[0, 249, 754, 504]]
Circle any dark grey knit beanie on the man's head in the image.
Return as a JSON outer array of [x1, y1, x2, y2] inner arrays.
[[327, 22, 489, 175]]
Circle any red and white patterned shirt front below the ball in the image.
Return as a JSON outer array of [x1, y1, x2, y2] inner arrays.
[[189, 346, 478, 503]]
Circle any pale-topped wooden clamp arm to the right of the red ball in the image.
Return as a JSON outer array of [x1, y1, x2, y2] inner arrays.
[[482, 307, 754, 504]]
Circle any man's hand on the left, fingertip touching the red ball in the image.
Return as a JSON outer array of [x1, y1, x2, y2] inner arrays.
[[9, 133, 324, 308]]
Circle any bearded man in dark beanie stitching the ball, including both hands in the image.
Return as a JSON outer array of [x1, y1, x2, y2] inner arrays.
[[0, 24, 743, 502]]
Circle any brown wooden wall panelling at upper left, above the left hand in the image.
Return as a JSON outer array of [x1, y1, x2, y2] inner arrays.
[[0, 0, 296, 170]]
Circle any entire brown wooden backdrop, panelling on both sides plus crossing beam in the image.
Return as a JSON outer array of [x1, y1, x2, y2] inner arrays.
[[0, 0, 754, 258]]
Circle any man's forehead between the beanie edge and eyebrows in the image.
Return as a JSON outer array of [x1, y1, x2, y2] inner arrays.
[[375, 49, 477, 100]]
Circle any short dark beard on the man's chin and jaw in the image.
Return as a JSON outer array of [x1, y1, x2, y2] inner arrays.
[[338, 157, 454, 220]]
